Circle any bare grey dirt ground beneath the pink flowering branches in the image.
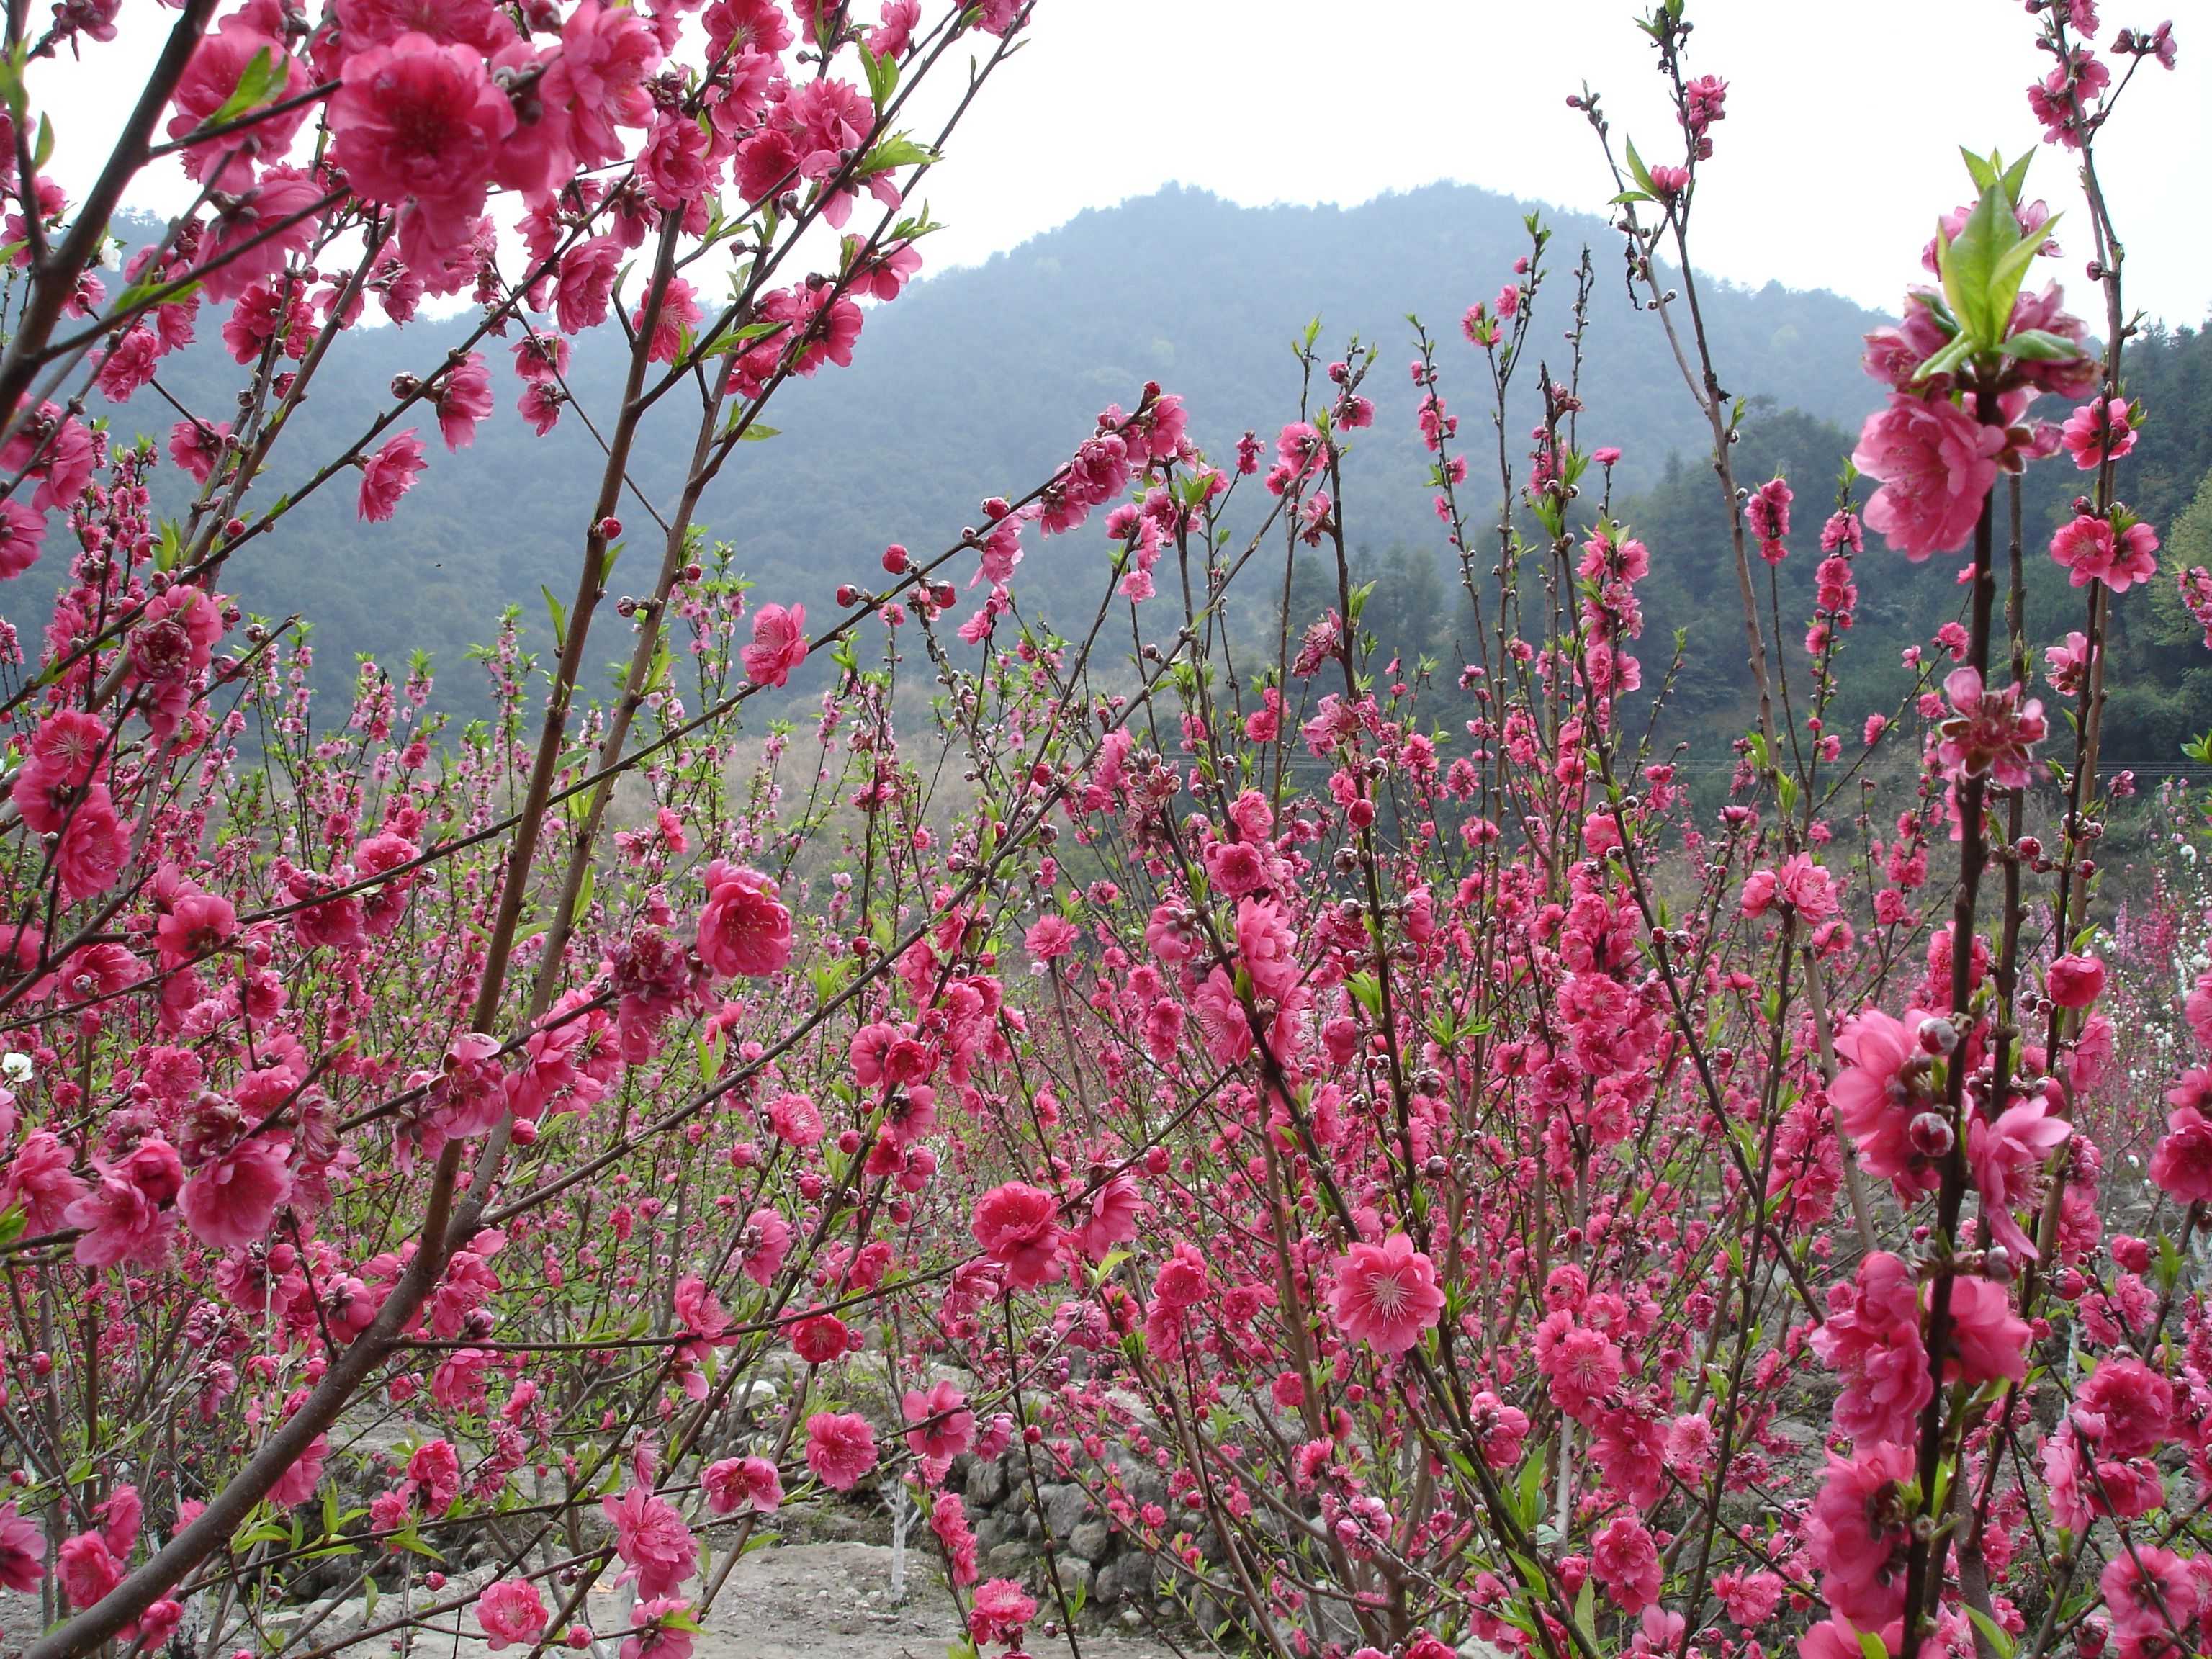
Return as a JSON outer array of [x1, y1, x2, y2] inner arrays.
[[0, 1544, 1174, 1659]]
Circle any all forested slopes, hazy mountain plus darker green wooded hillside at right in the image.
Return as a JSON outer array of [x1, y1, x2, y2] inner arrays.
[[9, 186, 2212, 765]]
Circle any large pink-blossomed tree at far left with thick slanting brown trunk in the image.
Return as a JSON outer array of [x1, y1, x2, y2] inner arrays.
[[0, 0, 1084, 1653]]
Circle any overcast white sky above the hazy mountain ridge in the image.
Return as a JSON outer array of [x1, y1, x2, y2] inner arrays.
[[33, 0, 2212, 323]]
